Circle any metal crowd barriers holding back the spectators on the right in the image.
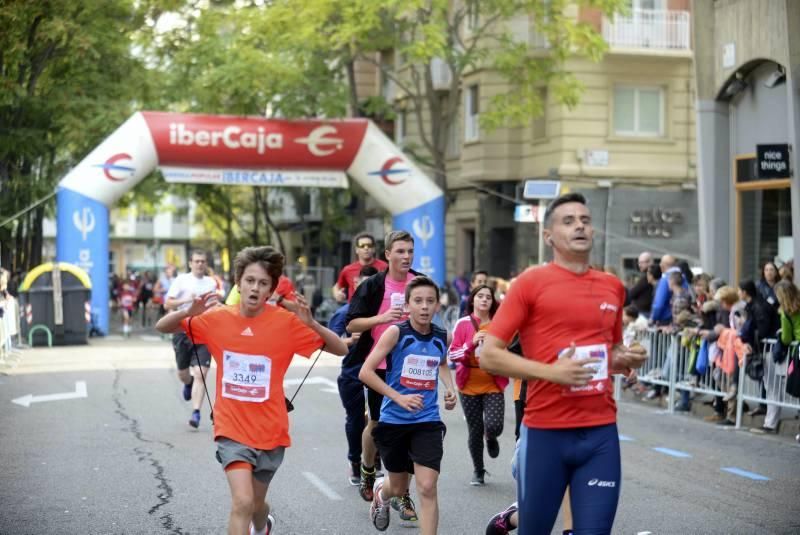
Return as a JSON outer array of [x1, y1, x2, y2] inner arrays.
[[628, 329, 800, 428]]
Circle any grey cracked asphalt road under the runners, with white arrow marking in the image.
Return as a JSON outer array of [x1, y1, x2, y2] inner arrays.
[[0, 336, 800, 535]]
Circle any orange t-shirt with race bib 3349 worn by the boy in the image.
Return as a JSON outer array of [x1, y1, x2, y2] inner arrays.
[[182, 305, 323, 450]]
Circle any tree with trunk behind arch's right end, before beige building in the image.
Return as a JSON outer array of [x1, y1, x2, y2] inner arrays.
[[269, 0, 626, 190]]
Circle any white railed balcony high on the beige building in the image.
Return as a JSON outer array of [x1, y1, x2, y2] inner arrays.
[[603, 9, 691, 52]]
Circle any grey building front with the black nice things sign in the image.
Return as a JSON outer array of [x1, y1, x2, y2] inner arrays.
[[693, 0, 800, 281]]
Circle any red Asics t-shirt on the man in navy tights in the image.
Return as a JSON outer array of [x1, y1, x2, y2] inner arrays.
[[489, 264, 625, 429]]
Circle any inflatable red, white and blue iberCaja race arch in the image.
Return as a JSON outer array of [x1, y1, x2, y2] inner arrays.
[[56, 112, 445, 333]]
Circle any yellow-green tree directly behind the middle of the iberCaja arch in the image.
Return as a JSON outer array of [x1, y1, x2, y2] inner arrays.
[[137, 2, 356, 266]]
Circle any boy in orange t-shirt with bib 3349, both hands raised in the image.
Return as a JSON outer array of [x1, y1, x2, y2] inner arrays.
[[156, 247, 347, 535]]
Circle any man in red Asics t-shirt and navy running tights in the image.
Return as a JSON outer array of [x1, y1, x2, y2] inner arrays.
[[480, 193, 647, 535]]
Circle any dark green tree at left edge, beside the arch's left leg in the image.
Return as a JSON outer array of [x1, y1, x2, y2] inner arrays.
[[0, 0, 154, 270]]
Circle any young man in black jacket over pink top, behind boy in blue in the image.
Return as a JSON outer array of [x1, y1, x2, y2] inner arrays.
[[340, 230, 419, 520]]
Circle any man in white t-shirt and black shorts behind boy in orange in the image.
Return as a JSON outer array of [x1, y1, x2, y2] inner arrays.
[[165, 251, 222, 428]]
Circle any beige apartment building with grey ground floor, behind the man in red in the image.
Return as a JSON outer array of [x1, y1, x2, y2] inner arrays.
[[366, 0, 699, 277]]
